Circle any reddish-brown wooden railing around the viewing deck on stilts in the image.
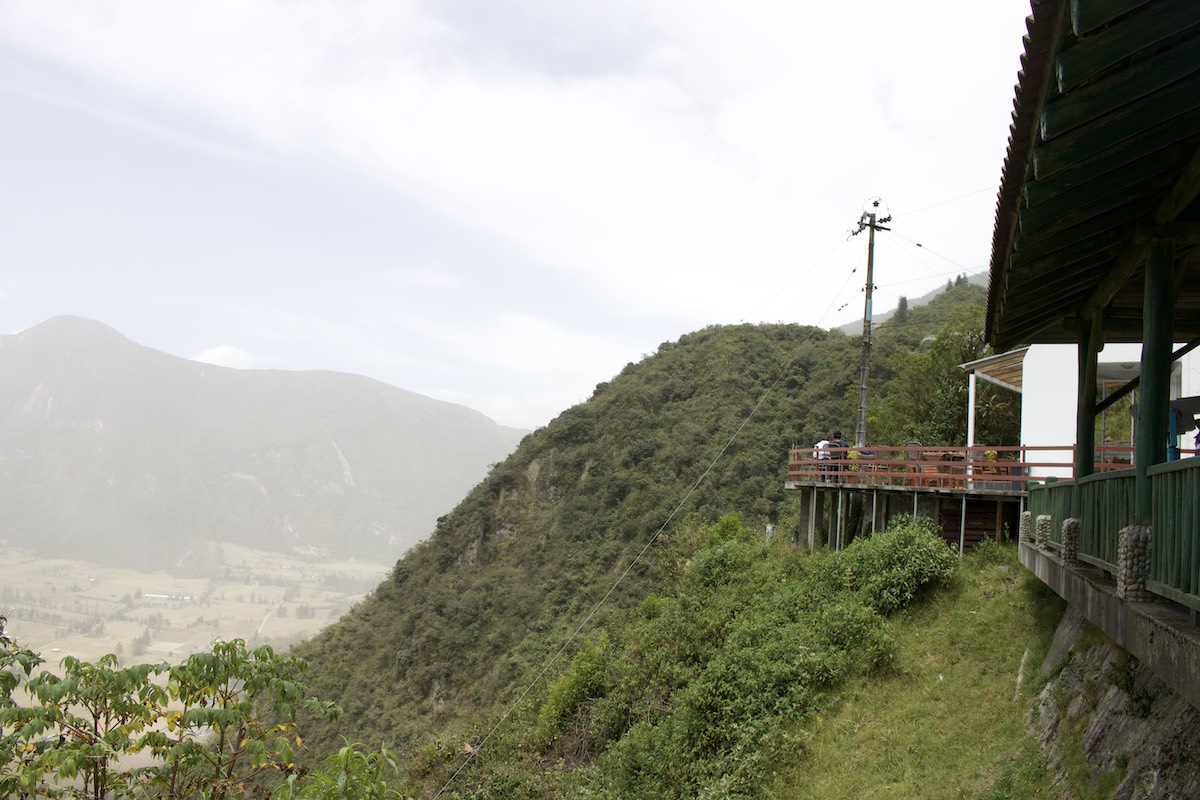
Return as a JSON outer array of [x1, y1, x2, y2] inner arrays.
[[787, 445, 1132, 493]]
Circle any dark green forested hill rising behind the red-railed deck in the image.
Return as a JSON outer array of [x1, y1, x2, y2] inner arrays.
[[298, 284, 1012, 754]]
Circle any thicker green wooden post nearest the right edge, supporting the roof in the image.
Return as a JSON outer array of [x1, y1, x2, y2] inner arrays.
[[1134, 239, 1175, 524]]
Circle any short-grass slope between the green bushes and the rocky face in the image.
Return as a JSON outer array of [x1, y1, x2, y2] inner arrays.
[[768, 547, 1062, 800]]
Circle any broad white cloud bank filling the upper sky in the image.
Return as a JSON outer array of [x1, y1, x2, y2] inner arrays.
[[4, 0, 1019, 318]]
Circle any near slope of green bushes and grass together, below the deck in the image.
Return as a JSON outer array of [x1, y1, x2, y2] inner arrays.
[[413, 518, 1070, 800]]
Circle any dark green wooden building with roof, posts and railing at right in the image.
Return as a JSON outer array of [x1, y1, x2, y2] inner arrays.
[[986, 0, 1200, 708]]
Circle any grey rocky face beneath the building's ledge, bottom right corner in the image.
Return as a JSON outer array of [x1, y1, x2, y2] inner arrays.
[[1031, 609, 1200, 800]]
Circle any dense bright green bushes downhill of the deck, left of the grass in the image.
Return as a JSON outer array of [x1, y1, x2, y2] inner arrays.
[[436, 516, 958, 800]]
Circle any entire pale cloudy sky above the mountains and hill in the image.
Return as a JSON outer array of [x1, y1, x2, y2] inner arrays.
[[0, 0, 1030, 429]]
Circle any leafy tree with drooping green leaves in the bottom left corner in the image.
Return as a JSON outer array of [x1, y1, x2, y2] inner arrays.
[[0, 637, 340, 800]]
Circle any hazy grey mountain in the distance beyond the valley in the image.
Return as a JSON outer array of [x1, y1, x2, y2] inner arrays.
[[0, 317, 524, 571]]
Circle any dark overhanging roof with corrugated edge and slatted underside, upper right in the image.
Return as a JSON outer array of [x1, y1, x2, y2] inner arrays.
[[985, 0, 1200, 349]]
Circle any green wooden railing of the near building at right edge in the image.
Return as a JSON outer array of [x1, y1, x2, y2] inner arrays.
[[1028, 451, 1200, 610]]
